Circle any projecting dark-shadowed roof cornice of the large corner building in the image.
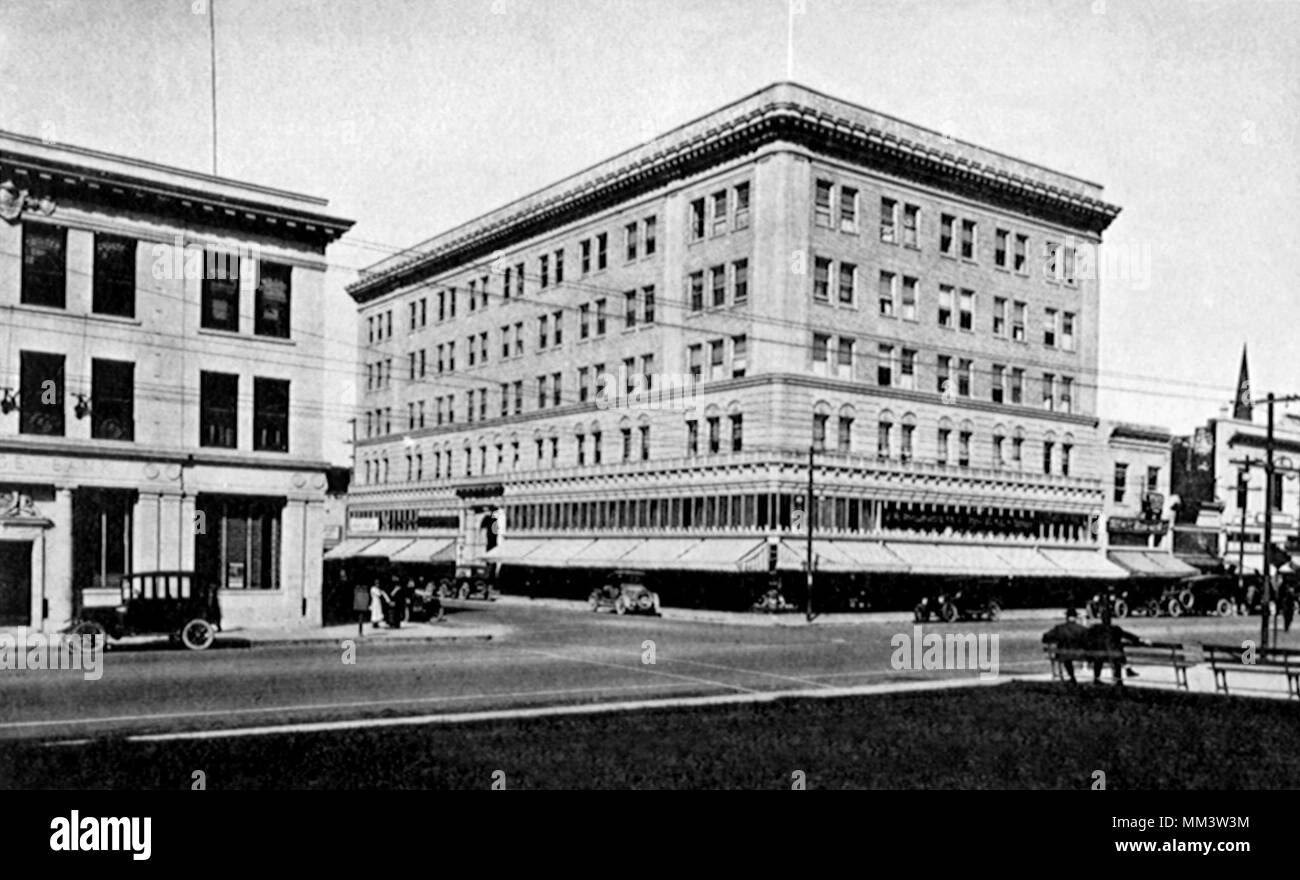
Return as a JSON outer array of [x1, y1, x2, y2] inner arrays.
[[348, 83, 1119, 303]]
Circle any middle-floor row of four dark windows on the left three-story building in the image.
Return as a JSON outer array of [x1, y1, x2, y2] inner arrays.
[[0, 351, 289, 452]]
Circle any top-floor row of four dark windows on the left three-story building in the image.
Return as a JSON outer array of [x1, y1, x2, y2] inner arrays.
[[12, 222, 293, 339]]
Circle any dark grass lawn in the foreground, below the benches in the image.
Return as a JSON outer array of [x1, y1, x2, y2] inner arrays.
[[0, 684, 1300, 790]]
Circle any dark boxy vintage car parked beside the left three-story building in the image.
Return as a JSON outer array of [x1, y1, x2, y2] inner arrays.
[[68, 571, 221, 651]]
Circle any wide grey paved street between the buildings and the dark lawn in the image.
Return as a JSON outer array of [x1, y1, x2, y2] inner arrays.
[[0, 602, 1300, 741]]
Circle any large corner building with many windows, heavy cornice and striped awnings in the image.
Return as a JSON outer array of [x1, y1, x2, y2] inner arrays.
[[338, 83, 1122, 610]]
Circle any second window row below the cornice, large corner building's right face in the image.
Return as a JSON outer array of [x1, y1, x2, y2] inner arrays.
[[813, 256, 1079, 351]]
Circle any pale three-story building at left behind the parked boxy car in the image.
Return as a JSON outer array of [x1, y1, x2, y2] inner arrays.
[[0, 126, 351, 630]]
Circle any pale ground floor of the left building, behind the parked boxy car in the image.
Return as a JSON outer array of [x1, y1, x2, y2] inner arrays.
[[0, 452, 325, 632]]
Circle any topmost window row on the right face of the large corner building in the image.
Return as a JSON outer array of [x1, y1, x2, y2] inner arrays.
[[813, 178, 1078, 285]]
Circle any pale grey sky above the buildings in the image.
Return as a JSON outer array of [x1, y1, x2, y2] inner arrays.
[[0, 0, 1300, 461]]
